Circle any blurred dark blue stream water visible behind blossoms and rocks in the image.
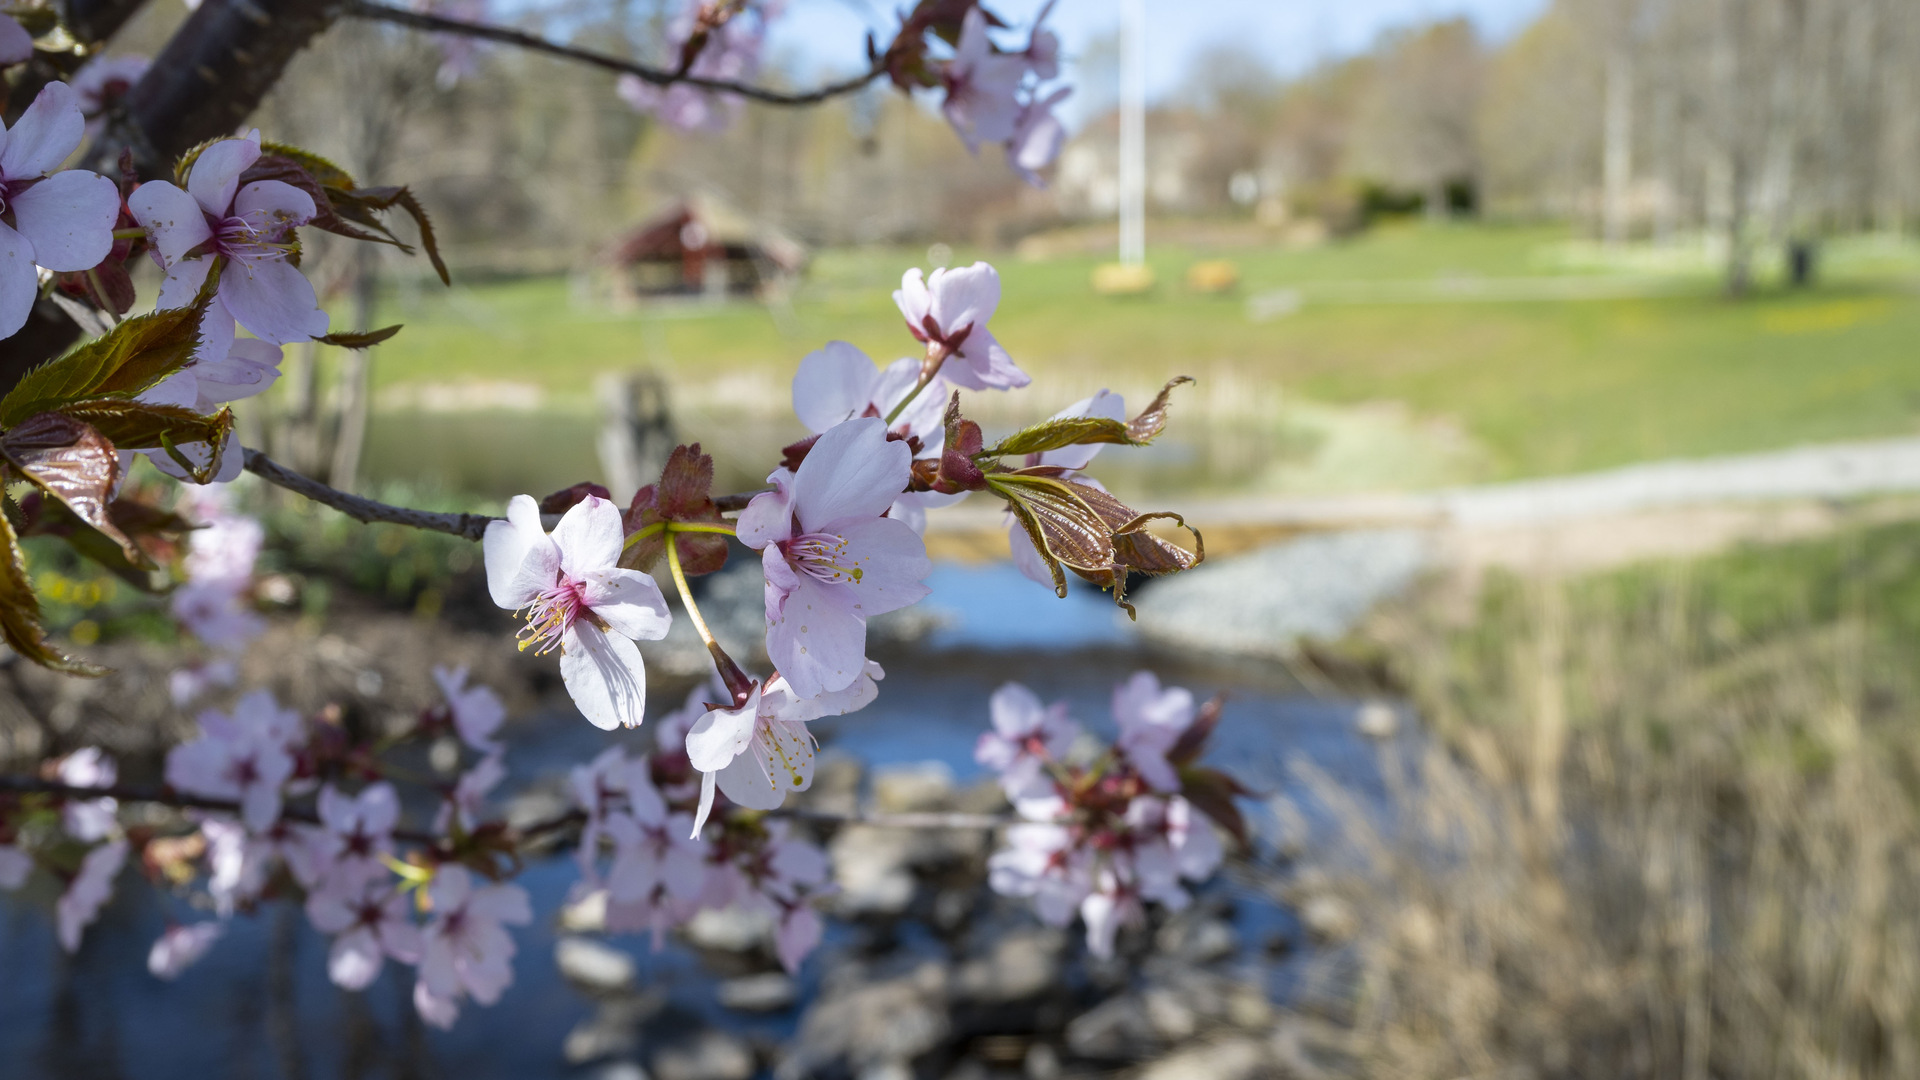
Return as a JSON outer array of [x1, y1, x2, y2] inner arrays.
[[0, 567, 1384, 1080]]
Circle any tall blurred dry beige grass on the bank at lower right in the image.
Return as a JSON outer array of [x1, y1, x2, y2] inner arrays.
[[1298, 527, 1920, 1080]]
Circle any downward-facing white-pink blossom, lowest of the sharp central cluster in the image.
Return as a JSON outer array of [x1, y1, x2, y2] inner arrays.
[[687, 661, 887, 836]]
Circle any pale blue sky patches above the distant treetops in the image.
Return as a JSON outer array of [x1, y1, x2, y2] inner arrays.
[[774, 0, 1548, 122]]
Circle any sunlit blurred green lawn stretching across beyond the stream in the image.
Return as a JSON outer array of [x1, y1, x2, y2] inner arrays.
[[362, 225, 1920, 482]]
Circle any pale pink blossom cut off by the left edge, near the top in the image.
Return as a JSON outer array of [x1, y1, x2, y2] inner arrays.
[[0, 80, 119, 338]]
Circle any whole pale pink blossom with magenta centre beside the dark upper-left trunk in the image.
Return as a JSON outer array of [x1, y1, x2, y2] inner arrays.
[[127, 131, 328, 344]]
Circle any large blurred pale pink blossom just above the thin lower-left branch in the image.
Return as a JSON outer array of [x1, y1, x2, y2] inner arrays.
[[167, 690, 301, 832]]
